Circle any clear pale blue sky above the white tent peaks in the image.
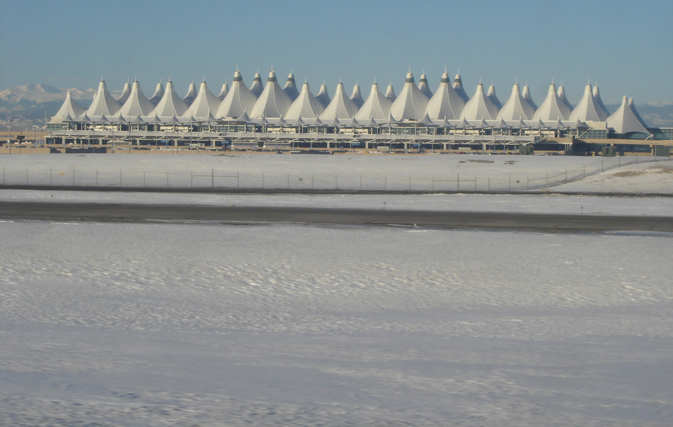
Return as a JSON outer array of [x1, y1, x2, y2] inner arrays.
[[0, 0, 673, 103]]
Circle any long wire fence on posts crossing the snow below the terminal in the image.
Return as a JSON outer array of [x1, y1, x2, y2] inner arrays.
[[2, 156, 670, 192]]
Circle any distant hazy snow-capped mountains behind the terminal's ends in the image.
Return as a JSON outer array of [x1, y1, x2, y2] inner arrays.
[[0, 83, 673, 132]]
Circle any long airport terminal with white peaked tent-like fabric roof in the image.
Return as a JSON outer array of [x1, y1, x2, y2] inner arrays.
[[47, 70, 673, 155]]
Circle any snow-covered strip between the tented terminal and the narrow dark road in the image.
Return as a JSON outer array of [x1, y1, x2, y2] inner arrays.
[[0, 153, 673, 194]]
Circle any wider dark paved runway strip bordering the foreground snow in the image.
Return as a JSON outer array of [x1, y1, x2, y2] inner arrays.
[[0, 202, 673, 232]]
